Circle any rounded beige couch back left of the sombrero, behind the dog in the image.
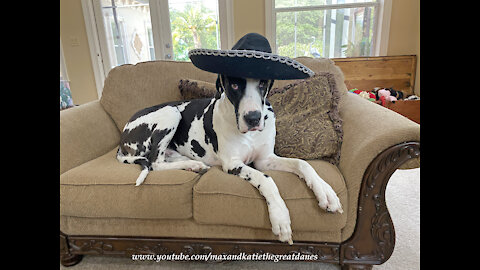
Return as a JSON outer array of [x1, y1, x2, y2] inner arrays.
[[100, 60, 216, 131]]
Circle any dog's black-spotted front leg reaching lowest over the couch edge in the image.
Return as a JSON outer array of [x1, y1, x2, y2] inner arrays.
[[222, 161, 293, 245]]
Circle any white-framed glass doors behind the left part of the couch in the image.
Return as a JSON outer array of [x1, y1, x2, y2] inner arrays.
[[91, 0, 231, 70]]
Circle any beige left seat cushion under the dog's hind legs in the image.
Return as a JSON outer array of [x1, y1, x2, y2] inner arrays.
[[60, 148, 199, 219]]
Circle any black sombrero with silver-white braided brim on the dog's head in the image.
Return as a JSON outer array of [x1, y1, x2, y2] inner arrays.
[[188, 33, 315, 80]]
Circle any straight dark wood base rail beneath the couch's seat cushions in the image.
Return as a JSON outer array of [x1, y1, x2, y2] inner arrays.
[[64, 236, 340, 263]]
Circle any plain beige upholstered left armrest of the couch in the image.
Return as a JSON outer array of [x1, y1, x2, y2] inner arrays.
[[60, 100, 120, 174]]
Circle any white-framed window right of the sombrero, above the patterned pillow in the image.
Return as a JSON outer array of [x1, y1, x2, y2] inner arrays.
[[266, 0, 384, 58]]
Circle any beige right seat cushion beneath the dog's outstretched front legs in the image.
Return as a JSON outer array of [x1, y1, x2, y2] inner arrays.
[[193, 160, 348, 232]]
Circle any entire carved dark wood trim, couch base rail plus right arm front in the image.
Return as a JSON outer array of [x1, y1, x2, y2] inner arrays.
[[60, 142, 420, 270]]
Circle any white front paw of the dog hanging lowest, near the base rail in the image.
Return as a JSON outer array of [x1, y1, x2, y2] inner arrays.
[[268, 201, 293, 245]]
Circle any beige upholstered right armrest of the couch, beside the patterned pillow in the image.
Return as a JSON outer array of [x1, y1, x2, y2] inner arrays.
[[338, 93, 420, 241]]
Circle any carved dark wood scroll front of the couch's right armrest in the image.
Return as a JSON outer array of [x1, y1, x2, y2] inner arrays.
[[340, 142, 420, 269]]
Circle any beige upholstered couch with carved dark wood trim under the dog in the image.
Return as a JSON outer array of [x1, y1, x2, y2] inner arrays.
[[60, 58, 420, 269]]
